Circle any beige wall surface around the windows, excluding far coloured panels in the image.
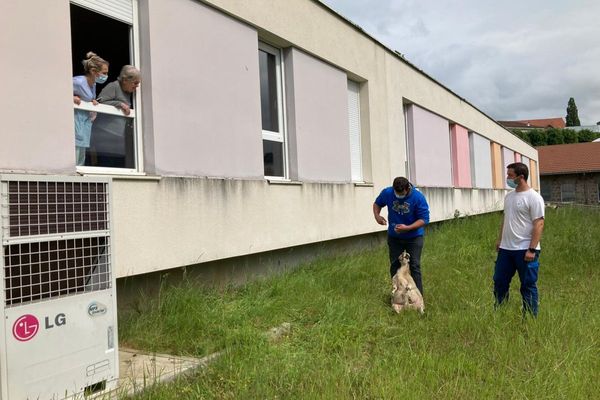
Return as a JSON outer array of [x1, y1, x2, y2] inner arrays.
[[0, 0, 538, 277]]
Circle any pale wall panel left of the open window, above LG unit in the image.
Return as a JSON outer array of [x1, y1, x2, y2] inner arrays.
[[0, 0, 75, 173]]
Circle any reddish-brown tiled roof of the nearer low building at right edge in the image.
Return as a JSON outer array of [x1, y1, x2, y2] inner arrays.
[[536, 142, 600, 175]]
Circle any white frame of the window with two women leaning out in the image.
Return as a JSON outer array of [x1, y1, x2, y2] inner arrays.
[[69, 0, 146, 176]]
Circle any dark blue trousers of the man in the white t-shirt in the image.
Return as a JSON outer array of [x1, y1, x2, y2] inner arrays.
[[494, 249, 540, 316]]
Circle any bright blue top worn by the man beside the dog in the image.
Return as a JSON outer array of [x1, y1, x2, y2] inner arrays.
[[375, 186, 429, 239]]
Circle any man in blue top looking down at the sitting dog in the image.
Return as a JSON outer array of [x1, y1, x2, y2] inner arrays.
[[373, 176, 429, 294]]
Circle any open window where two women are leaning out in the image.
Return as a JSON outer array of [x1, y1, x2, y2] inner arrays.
[[70, 0, 141, 173]]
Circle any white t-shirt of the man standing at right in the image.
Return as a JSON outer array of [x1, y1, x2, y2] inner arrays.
[[500, 189, 544, 250]]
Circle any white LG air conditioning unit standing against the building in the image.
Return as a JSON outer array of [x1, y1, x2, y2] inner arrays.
[[0, 174, 119, 400]]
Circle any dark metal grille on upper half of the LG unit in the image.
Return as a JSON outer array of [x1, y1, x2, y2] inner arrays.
[[0, 176, 113, 306]]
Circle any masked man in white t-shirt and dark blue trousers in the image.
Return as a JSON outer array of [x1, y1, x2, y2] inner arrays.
[[494, 163, 544, 316]]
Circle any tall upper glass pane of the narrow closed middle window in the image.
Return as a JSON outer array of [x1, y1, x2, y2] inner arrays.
[[258, 50, 279, 132]]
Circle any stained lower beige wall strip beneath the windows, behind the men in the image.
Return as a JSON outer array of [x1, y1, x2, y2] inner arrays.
[[113, 177, 505, 277]]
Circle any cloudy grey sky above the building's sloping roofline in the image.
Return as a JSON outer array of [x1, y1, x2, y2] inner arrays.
[[322, 0, 600, 125]]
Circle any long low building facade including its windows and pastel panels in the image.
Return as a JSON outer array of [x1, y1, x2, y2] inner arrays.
[[0, 0, 539, 277]]
